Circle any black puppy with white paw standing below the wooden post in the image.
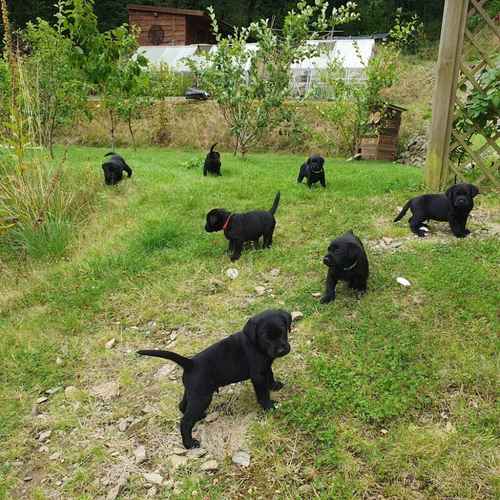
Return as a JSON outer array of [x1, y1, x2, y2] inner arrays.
[[394, 183, 479, 238]]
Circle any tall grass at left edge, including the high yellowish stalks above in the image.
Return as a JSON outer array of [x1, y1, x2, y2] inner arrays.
[[0, 0, 98, 258]]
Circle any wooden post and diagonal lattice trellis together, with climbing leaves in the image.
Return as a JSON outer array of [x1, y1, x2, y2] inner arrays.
[[425, 0, 500, 190]]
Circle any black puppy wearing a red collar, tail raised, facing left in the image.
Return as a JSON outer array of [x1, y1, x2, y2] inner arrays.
[[205, 191, 280, 261]]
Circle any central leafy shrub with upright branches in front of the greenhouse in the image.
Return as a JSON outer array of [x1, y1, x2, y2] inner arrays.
[[190, 0, 357, 155]]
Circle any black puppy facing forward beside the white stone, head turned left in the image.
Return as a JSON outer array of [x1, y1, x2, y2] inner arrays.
[[321, 231, 369, 304]]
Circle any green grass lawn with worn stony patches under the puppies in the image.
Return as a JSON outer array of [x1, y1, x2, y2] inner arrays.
[[0, 148, 500, 499]]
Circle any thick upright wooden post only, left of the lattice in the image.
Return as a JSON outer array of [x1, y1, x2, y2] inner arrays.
[[425, 0, 469, 190]]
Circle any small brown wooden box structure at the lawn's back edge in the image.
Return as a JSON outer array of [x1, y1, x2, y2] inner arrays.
[[360, 104, 405, 161]]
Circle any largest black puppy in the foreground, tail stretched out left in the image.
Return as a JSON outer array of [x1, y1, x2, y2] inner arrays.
[[137, 310, 292, 448]]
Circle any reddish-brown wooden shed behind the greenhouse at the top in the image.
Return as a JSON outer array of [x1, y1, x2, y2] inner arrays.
[[128, 5, 215, 46]]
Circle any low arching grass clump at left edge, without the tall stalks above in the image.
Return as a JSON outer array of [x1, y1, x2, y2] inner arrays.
[[0, 153, 99, 258]]
